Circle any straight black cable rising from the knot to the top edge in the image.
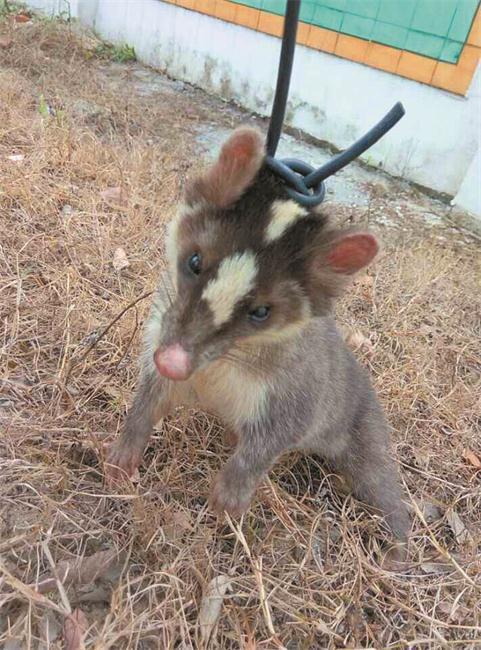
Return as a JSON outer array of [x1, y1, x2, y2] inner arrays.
[[266, 0, 301, 157]]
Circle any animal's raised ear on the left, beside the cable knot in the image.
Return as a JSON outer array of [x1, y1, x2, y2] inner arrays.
[[186, 127, 265, 208]]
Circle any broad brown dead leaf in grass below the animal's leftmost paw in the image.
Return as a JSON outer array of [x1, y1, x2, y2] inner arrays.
[[37, 549, 123, 594]]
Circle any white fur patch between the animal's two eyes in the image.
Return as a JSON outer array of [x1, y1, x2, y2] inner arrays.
[[202, 251, 257, 327]]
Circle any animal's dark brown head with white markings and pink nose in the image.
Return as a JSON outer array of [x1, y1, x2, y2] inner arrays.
[[154, 128, 378, 380]]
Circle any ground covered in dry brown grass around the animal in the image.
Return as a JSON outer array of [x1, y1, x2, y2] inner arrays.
[[0, 11, 481, 650]]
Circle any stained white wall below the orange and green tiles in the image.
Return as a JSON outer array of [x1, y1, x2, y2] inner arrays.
[[28, 0, 481, 219]]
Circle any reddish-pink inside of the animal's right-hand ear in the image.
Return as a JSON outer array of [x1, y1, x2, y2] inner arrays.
[[326, 232, 379, 275]]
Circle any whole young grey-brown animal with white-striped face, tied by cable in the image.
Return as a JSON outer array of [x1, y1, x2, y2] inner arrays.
[[108, 128, 409, 542]]
